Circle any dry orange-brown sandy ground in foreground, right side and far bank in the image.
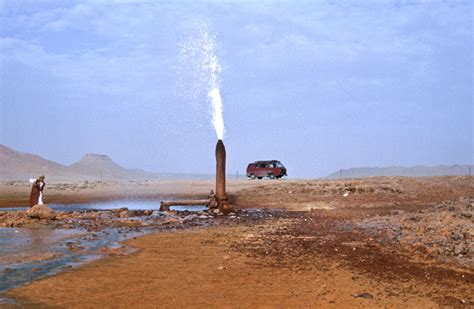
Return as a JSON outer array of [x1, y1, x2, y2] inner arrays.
[[0, 177, 474, 308]]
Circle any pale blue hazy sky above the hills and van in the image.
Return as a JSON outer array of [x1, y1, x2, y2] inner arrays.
[[0, 0, 474, 177]]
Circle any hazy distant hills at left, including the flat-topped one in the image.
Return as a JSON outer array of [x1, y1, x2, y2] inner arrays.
[[0, 144, 158, 181]]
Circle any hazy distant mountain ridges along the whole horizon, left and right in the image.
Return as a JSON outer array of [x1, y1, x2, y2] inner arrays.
[[0, 144, 474, 181]]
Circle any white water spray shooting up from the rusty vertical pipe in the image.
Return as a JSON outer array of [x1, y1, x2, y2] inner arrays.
[[180, 25, 225, 139]]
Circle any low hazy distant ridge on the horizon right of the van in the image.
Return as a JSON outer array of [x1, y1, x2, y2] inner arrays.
[[325, 164, 474, 179]]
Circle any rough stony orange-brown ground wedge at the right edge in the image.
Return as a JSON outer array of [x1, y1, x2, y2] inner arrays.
[[357, 198, 474, 267]]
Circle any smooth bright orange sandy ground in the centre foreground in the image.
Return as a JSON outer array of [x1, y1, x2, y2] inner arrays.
[[6, 228, 436, 308]]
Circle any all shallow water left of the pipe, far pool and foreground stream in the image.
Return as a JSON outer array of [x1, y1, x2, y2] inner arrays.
[[0, 200, 211, 292]]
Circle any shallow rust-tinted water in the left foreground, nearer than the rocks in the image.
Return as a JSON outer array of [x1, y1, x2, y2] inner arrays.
[[0, 227, 148, 292]]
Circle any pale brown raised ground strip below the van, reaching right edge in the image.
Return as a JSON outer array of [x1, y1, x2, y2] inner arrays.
[[231, 176, 474, 212]]
